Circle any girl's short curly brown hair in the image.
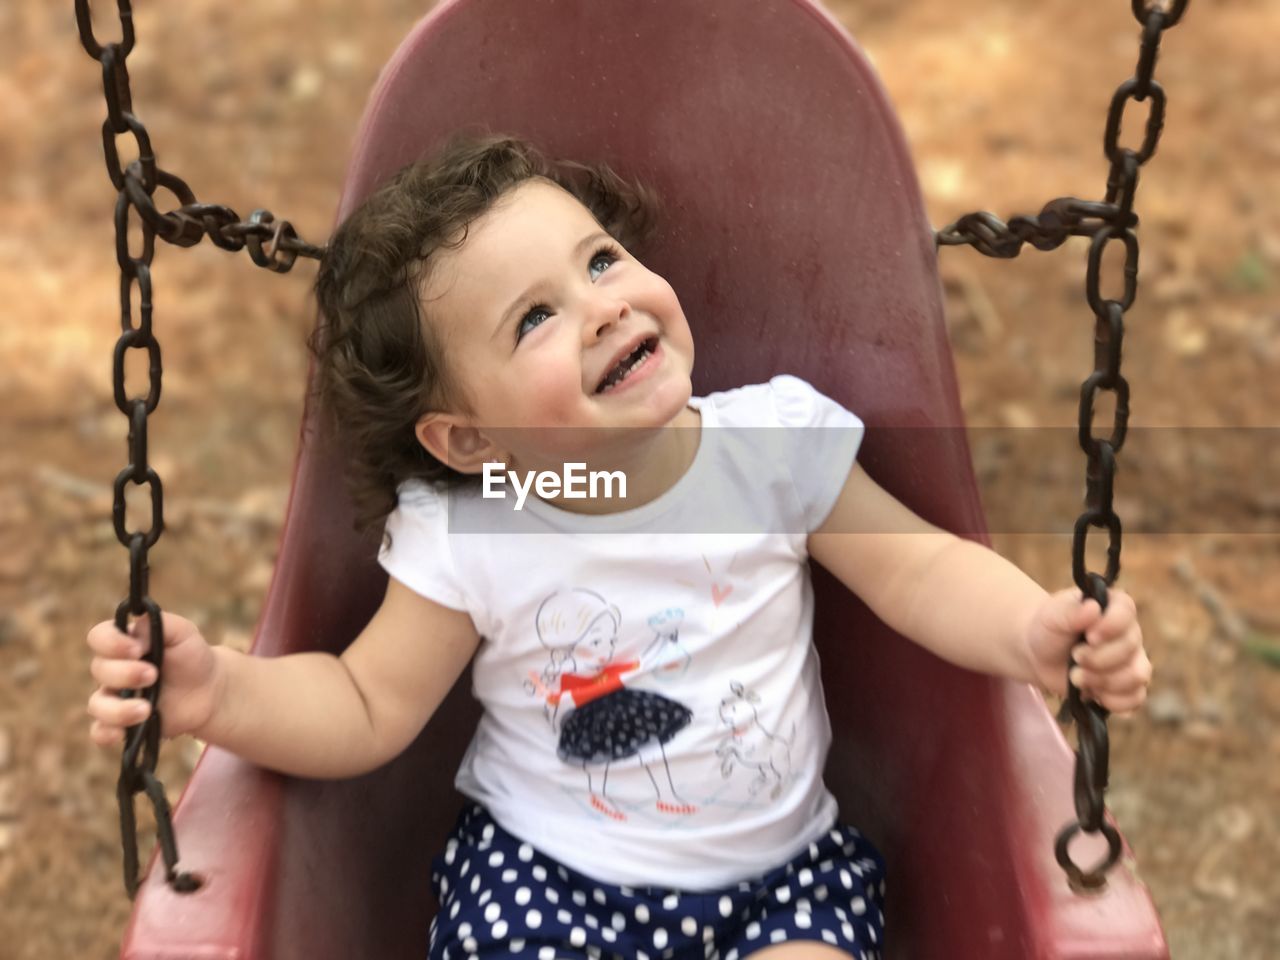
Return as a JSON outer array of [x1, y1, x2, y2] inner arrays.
[[308, 136, 655, 531]]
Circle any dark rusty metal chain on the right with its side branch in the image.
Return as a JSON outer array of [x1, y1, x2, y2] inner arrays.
[[937, 0, 1189, 891]]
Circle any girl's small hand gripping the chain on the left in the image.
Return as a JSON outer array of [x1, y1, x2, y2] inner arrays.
[[87, 613, 220, 746]]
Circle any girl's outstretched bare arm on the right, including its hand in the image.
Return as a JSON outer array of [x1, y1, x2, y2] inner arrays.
[[809, 463, 1151, 709]]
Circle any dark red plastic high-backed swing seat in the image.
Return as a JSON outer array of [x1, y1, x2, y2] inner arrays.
[[123, 0, 1167, 960]]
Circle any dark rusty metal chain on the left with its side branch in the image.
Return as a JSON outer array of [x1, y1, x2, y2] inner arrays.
[[76, 0, 324, 897]]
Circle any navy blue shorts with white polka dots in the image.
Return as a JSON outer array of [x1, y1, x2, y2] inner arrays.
[[429, 804, 884, 960]]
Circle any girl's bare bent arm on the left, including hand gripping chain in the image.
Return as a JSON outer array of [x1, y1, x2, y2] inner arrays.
[[88, 579, 480, 778]]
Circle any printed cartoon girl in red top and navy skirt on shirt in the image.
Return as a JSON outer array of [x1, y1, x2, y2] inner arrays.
[[525, 588, 698, 820]]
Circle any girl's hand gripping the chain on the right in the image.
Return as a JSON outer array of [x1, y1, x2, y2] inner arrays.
[[1027, 588, 1152, 716]]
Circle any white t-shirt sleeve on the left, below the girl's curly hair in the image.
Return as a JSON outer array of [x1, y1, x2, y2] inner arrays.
[[378, 484, 467, 611]]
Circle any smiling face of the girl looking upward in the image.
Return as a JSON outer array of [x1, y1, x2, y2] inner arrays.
[[422, 180, 694, 468]]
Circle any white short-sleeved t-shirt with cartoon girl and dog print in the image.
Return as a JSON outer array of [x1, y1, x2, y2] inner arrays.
[[379, 376, 863, 890]]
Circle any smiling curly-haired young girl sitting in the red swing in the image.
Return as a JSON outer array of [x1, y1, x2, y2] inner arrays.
[[88, 138, 1151, 960]]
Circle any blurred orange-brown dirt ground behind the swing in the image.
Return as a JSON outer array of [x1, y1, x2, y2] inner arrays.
[[0, 0, 1280, 960]]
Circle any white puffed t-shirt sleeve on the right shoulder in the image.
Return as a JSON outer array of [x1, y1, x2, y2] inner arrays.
[[769, 375, 865, 534]]
